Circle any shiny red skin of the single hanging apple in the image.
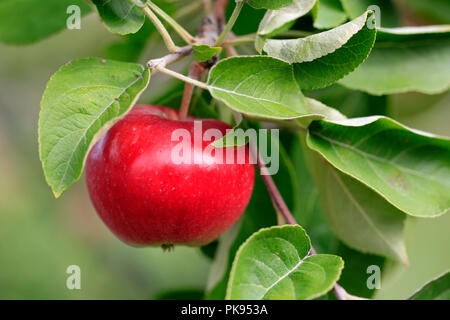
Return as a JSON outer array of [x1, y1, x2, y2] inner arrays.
[[86, 105, 255, 246]]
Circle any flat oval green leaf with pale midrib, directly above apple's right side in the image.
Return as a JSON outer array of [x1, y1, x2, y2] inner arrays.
[[208, 56, 309, 119]]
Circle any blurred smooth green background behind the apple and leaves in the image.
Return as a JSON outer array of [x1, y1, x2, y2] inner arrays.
[[0, 5, 450, 299]]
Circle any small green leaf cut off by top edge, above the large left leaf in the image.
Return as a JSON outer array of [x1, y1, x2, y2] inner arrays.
[[92, 0, 145, 35]]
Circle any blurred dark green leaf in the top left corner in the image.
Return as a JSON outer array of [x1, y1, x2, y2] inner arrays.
[[0, 0, 91, 44]]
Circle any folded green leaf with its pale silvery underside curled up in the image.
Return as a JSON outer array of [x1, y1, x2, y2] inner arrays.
[[264, 12, 376, 90]]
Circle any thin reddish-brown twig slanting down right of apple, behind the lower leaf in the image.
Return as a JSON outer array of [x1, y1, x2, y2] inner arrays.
[[250, 143, 354, 300]]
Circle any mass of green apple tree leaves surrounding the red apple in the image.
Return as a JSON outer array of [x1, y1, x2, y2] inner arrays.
[[0, 0, 450, 299]]
